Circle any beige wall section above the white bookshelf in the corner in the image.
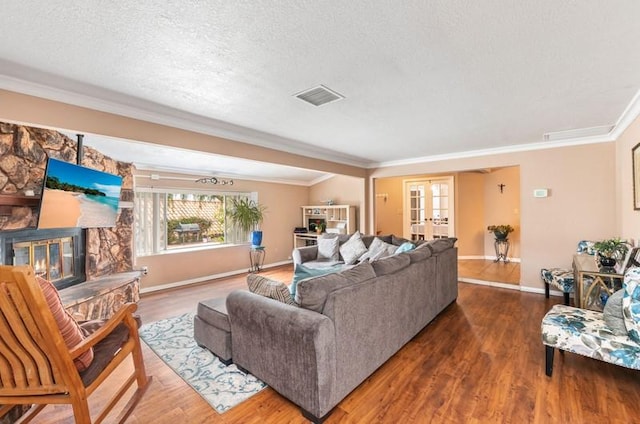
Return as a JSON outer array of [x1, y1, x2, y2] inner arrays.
[[310, 175, 366, 230]]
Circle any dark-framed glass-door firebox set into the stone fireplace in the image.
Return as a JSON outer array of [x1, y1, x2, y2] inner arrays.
[[0, 228, 86, 290]]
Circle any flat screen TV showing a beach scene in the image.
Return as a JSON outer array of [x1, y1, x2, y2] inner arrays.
[[38, 158, 122, 229]]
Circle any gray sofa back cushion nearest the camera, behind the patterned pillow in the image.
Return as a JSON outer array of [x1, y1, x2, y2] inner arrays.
[[295, 262, 376, 312]]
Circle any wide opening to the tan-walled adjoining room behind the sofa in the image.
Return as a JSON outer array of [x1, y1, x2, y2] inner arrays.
[[374, 166, 521, 287]]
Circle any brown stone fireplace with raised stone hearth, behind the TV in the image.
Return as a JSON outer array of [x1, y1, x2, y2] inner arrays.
[[0, 122, 140, 319]]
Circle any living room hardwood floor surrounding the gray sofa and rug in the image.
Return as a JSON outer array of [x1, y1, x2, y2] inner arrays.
[[32, 267, 640, 424]]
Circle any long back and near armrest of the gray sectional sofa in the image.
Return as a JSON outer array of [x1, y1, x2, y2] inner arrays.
[[226, 239, 458, 423]]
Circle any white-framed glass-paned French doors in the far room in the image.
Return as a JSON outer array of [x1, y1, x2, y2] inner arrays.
[[403, 177, 454, 240]]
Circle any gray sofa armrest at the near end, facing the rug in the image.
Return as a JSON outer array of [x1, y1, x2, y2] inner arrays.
[[227, 290, 339, 417]]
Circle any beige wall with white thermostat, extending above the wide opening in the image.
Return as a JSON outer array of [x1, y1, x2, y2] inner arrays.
[[371, 143, 617, 289]]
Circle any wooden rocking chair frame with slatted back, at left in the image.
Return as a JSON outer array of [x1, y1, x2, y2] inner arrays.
[[0, 266, 151, 424]]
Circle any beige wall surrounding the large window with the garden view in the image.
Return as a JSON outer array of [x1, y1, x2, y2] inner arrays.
[[135, 171, 309, 289]]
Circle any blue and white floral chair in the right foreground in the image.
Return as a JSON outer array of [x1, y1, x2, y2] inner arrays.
[[542, 267, 640, 376]]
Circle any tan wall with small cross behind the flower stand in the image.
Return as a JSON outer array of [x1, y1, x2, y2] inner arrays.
[[483, 166, 520, 258]]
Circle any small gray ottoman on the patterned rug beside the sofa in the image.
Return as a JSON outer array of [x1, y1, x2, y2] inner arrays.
[[193, 298, 232, 365]]
